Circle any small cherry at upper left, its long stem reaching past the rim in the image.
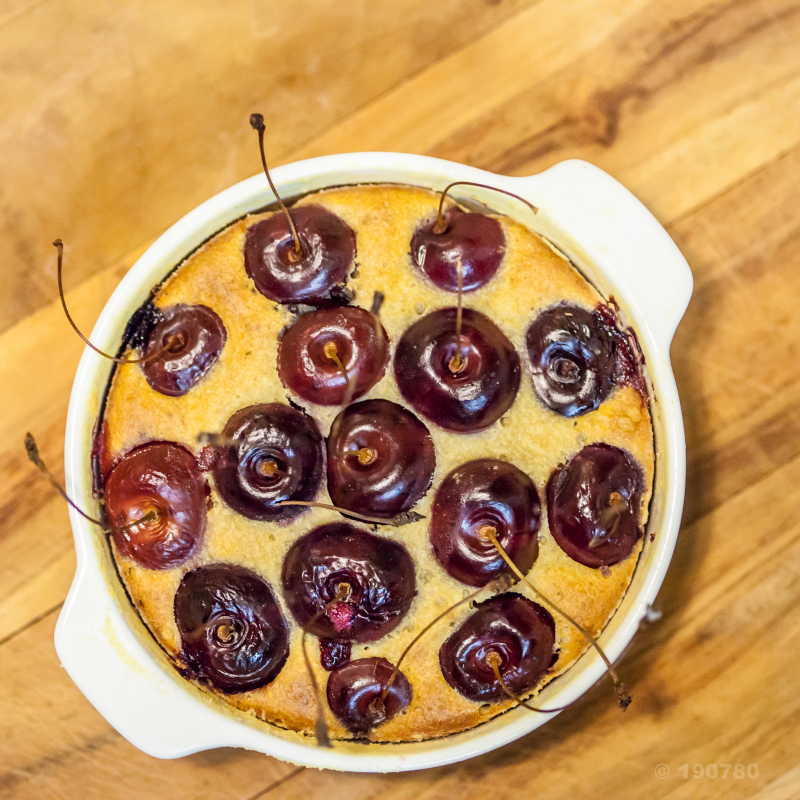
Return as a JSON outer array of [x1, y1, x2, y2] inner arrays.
[[142, 305, 227, 397]]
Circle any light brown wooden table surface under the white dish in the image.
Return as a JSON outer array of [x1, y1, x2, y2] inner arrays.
[[0, 0, 800, 800]]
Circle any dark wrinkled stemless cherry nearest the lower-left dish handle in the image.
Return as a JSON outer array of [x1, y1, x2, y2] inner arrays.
[[175, 564, 289, 693]]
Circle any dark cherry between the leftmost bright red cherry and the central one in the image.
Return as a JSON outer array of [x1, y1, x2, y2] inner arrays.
[[213, 403, 323, 522]]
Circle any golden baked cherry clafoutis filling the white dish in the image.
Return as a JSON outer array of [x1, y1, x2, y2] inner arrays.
[[94, 169, 654, 742]]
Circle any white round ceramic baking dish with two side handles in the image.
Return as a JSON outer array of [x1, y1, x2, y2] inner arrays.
[[55, 153, 692, 772]]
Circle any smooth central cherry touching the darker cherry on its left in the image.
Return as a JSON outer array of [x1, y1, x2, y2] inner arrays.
[[328, 400, 436, 519]]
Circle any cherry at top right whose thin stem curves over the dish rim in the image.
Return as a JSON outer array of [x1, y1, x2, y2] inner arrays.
[[411, 207, 506, 292]]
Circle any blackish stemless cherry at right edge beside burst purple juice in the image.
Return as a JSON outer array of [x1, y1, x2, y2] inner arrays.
[[526, 303, 615, 417]]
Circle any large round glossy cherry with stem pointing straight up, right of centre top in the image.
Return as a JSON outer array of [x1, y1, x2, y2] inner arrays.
[[394, 308, 520, 433]]
